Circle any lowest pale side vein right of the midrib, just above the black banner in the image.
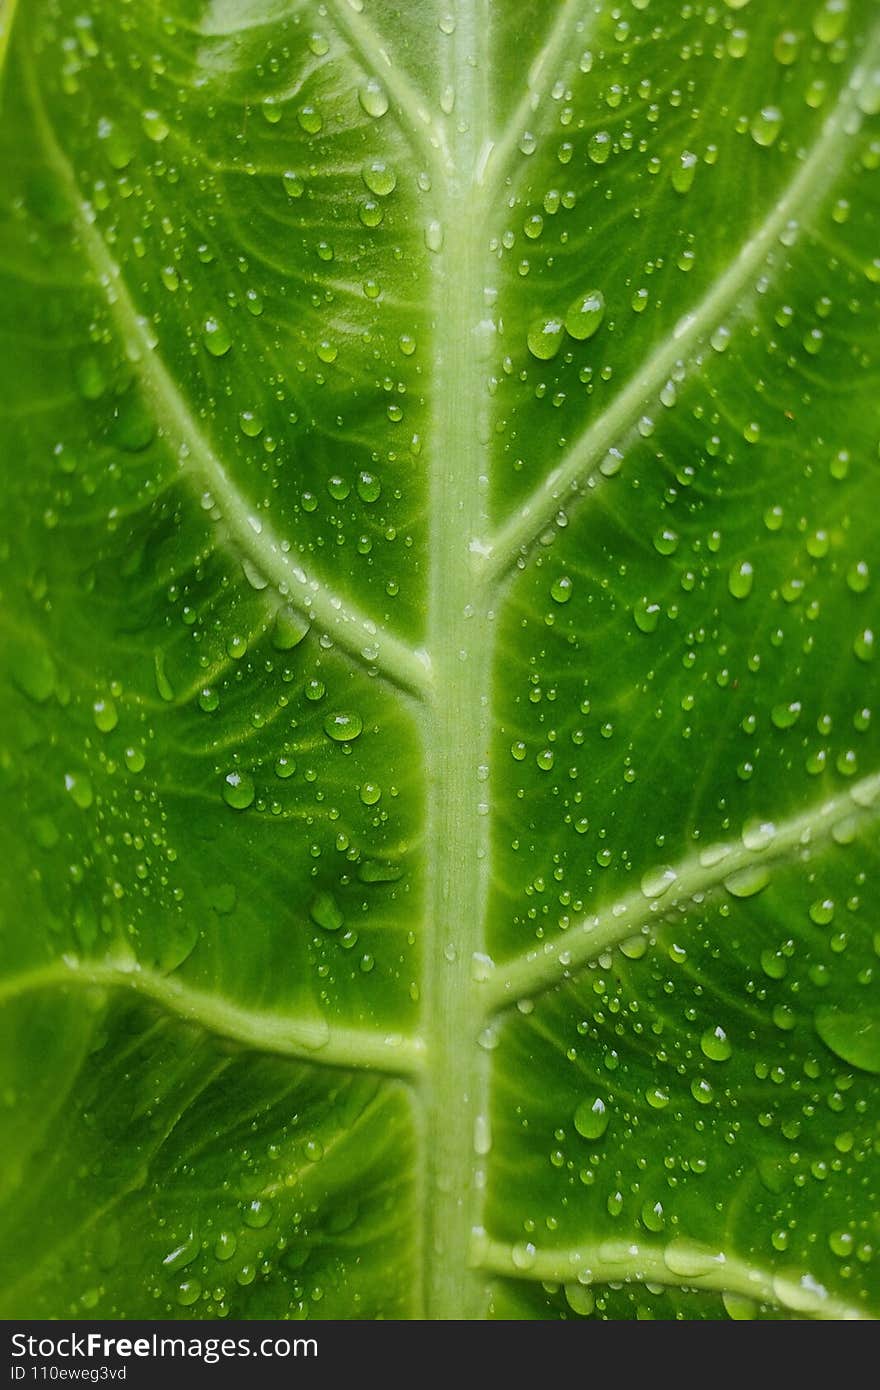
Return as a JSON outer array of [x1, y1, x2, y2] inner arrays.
[[471, 1233, 873, 1322]]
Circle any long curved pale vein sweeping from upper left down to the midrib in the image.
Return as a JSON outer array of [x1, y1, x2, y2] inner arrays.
[[23, 61, 431, 695]]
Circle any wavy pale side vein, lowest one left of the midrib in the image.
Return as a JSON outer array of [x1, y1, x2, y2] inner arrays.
[[0, 958, 424, 1076]]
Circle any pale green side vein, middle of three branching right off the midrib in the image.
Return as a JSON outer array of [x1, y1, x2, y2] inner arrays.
[[482, 773, 880, 1012]]
